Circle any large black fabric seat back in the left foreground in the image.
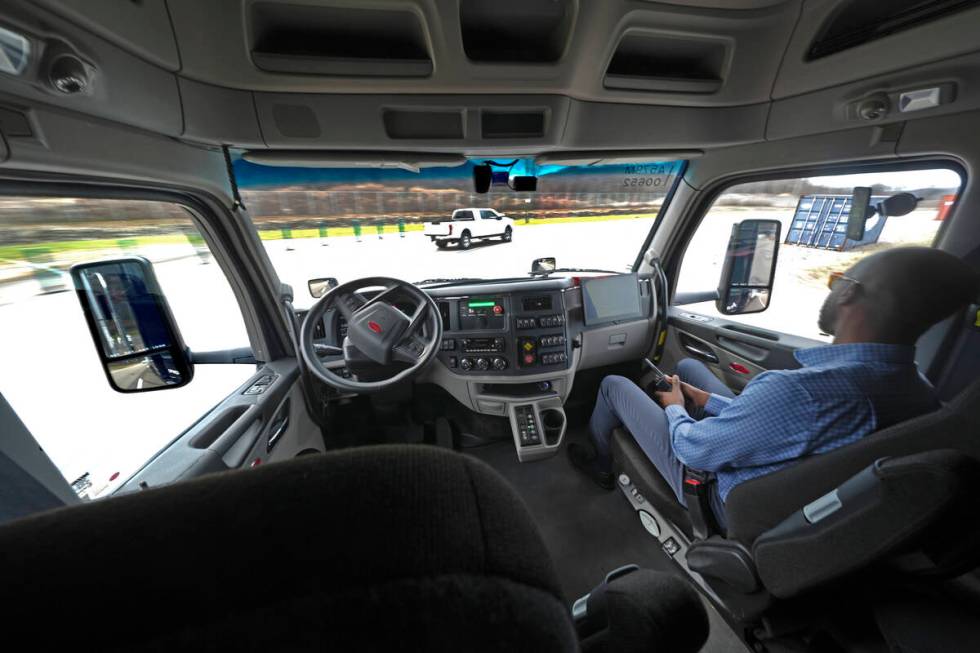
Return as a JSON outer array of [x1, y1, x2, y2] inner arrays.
[[0, 446, 578, 651]]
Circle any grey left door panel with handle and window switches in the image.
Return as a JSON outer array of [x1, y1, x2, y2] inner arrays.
[[117, 359, 325, 493]]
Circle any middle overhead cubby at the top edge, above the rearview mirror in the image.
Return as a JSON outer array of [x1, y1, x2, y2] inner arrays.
[[459, 0, 574, 63]]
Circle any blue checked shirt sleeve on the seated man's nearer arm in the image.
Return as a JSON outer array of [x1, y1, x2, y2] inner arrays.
[[666, 372, 814, 472]]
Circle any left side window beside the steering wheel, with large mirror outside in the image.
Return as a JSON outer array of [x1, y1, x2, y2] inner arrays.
[[0, 197, 255, 498]]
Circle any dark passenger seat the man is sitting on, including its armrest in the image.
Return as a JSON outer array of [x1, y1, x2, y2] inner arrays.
[[611, 379, 980, 619]]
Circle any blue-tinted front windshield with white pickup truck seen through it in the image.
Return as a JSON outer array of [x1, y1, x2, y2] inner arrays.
[[234, 159, 682, 308]]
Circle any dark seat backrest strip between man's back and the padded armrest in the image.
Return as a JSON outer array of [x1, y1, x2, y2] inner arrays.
[[725, 379, 980, 547]]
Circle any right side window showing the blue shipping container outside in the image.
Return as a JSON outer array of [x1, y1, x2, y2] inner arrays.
[[677, 168, 962, 342]]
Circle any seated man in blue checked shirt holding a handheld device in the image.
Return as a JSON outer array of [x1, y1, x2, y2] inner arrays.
[[569, 247, 980, 525]]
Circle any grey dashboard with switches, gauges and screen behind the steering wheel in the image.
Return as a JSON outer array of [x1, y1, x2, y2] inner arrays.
[[314, 275, 657, 462]]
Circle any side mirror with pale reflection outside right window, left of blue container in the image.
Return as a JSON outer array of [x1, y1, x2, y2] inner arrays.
[[715, 220, 781, 315]]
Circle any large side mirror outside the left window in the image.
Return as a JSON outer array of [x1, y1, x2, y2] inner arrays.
[[71, 257, 194, 392]]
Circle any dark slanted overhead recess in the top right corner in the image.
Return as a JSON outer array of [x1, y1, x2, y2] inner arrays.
[[807, 0, 980, 61]]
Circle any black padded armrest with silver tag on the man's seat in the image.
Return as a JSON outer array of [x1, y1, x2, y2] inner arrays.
[[752, 449, 980, 598]]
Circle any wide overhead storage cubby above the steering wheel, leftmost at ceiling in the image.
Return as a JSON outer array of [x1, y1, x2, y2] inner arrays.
[[251, 2, 432, 77]]
